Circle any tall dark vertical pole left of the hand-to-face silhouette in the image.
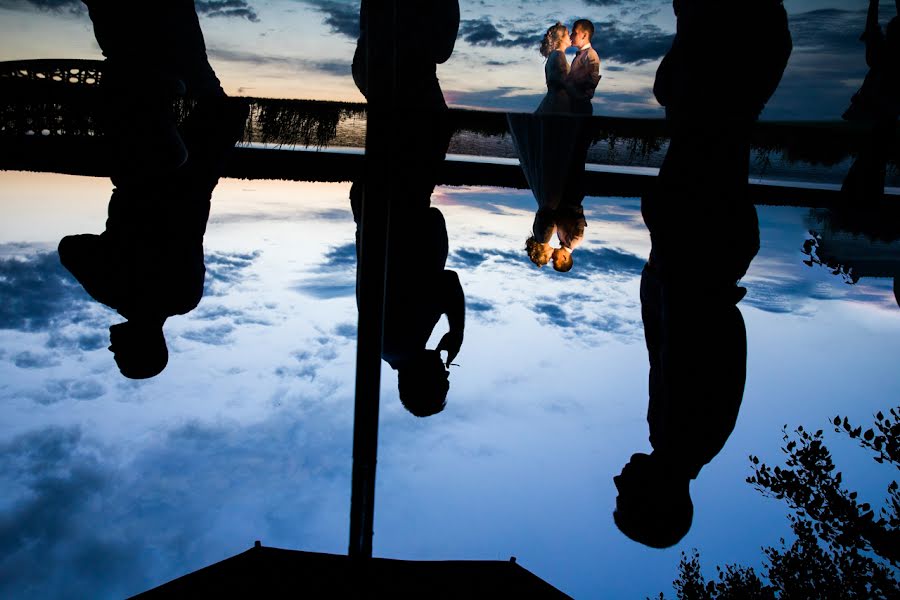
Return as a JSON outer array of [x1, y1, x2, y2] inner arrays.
[[349, 0, 398, 559]]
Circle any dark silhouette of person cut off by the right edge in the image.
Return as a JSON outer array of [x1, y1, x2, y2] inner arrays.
[[841, 0, 900, 205]]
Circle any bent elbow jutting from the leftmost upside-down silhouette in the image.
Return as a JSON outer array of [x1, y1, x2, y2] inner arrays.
[[57, 233, 121, 308]]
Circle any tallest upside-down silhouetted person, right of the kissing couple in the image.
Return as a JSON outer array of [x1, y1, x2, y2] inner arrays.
[[613, 0, 791, 548]]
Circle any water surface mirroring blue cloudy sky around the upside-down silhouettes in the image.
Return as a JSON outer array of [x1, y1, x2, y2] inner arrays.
[[0, 172, 900, 598]]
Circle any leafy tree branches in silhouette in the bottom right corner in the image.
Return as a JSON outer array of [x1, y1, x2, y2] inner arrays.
[[659, 407, 900, 600]]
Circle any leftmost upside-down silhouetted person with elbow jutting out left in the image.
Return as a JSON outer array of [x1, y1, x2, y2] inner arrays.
[[59, 0, 247, 379]]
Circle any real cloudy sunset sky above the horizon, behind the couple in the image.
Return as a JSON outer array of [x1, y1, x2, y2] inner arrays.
[[0, 0, 894, 120]]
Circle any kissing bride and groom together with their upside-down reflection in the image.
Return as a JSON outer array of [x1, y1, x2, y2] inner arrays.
[[508, 19, 600, 272]]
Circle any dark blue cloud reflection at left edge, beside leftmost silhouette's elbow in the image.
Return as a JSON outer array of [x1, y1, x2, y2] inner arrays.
[[0, 252, 90, 331]]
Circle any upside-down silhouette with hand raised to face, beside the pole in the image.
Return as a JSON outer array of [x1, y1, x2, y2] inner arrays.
[[350, 0, 465, 417]]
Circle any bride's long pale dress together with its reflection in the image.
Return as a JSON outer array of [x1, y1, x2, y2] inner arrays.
[[507, 50, 582, 243]]
